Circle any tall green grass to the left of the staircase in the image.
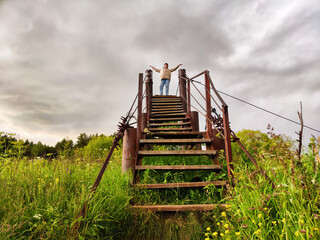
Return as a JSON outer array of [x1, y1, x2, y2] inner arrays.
[[0, 152, 132, 239]]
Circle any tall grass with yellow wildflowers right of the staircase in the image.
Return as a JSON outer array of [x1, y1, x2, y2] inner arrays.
[[205, 131, 320, 239]]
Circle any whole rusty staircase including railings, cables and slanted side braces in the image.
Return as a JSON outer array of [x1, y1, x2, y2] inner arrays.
[[74, 69, 275, 221]]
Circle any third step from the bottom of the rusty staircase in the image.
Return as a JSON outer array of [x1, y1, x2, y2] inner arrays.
[[135, 165, 222, 171]]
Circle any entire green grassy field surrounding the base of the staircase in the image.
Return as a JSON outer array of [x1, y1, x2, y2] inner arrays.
[[0, 131, 320, 240]]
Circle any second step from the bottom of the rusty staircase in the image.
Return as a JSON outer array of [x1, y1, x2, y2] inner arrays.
[[133, 181, 227, 189]]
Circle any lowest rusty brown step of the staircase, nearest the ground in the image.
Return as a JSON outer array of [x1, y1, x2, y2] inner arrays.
[[130, 204, 230, 212]]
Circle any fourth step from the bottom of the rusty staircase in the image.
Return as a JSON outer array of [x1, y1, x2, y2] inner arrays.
[[138, 150, 217, 156]]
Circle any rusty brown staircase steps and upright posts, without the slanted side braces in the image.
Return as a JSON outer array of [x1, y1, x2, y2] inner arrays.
[[123, 70, 232, 211]]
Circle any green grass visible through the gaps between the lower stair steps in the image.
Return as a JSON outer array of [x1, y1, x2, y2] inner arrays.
[[133, 151, 226, 205]]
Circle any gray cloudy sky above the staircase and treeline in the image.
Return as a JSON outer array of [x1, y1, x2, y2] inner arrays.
[[0, 0, 320, 144]]
